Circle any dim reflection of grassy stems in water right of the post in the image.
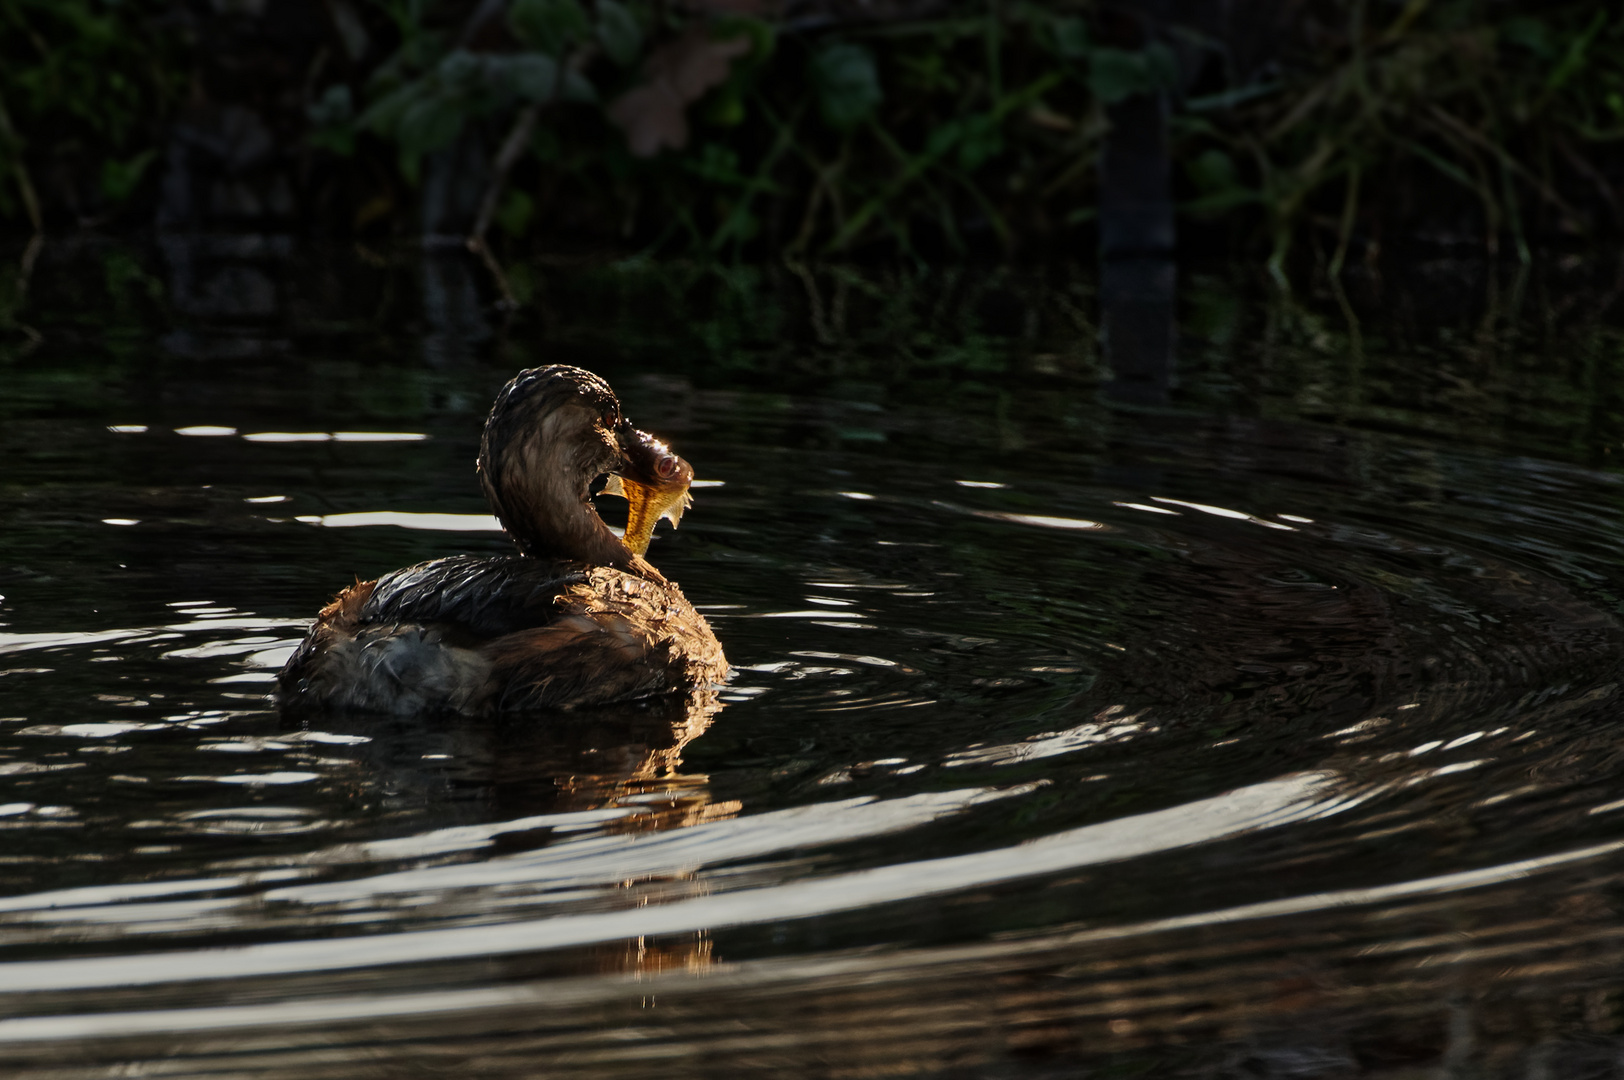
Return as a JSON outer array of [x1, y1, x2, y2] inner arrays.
[[1181, 260, 1624, 466]]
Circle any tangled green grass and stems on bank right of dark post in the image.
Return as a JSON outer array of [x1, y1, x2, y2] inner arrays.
[[1176, 0, 1624, 271]]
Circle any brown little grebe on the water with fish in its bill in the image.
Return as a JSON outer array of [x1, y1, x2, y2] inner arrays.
[[278, 364, 728, 713]]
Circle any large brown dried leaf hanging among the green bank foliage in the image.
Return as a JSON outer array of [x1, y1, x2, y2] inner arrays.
[[609, 26, 750, 158]]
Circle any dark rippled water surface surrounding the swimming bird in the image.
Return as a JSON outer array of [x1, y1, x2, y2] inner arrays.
[[0, 242, 1624, 1080]]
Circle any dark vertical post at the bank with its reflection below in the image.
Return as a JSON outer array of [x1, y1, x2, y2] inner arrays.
[[1099, 0, 1177, 406]]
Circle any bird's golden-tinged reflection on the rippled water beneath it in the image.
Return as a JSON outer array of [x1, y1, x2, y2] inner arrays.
[[284, 692, 742, 974]]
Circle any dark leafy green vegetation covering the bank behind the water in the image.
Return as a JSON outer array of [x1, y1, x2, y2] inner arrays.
[[0, 0, 1624, 268]]
